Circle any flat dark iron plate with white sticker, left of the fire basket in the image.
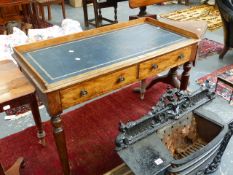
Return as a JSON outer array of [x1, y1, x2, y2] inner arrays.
[[117, 133, 174, 175]]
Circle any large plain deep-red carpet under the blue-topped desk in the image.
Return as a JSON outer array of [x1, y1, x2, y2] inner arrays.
[[0, 83, 167, 175]]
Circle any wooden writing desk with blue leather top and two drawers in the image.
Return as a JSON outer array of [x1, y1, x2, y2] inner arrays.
[[14, 18, 199, 174]]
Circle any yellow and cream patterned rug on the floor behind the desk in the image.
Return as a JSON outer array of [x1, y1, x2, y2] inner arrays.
[[160, 5, 222, 31]]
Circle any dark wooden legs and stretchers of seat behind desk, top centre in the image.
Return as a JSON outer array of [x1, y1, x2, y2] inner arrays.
[[82, 0, 117, 27]]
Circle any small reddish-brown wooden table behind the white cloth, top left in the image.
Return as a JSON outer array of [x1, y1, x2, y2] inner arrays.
[[36, 0, 66, 21]]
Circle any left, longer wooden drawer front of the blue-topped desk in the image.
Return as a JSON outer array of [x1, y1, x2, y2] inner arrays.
[[60, 66, 137, 109]]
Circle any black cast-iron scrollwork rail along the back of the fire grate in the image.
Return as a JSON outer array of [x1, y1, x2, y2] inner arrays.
[[116, 89, 215, 150]]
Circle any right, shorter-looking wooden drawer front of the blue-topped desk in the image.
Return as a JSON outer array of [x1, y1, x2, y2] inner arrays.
[[139, 46, 192, 79]]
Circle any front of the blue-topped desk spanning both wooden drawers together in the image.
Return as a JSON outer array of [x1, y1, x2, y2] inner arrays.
[[60, 45, 193, 110]]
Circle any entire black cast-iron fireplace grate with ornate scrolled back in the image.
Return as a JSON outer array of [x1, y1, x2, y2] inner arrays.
[[116, 89, 233, 175]]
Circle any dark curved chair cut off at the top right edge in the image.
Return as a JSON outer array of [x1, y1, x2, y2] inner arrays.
[[216, 0, 233, 58]]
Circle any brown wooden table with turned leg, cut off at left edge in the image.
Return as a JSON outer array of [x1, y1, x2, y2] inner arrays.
[[0, 60, 45, 145]]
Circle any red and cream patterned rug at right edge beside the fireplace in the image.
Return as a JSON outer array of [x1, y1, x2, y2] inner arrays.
[[197, 64, 233, 101]]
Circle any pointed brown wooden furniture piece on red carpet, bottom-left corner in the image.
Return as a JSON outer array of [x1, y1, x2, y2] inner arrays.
[[0, 157, 23, 175]]
